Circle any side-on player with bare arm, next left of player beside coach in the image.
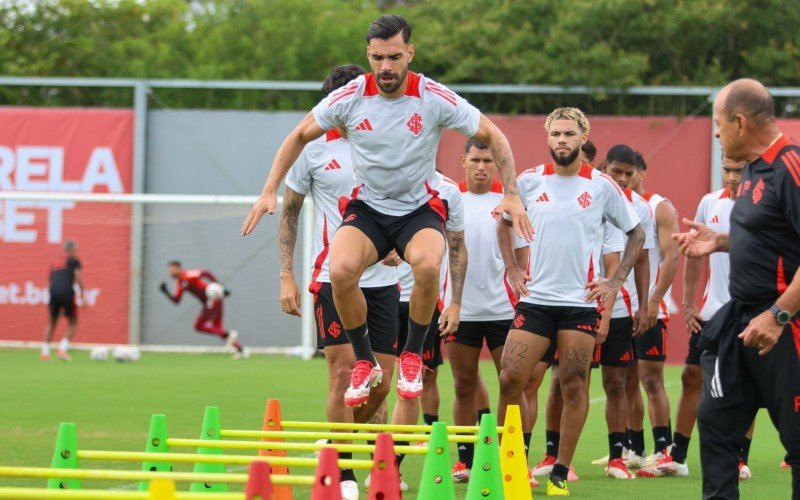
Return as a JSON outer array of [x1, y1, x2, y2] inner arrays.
[[626, 150, 680, 470]]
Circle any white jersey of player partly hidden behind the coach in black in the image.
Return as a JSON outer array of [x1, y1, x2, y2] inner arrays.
[[694, 188, 733, 321]]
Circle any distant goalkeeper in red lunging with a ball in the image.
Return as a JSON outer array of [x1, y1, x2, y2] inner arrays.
[[159, 260, 250, 359]]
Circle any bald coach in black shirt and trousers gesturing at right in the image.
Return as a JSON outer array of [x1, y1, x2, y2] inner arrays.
[[673, 79, 800, 500]]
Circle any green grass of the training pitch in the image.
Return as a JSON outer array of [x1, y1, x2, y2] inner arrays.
[[0, 350, 790, 499]]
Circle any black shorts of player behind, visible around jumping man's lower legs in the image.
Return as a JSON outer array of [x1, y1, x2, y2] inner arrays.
[[314, 283, 400, 355]]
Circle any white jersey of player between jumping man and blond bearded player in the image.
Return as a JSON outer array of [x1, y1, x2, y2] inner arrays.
[[461, 187, 527, 321]]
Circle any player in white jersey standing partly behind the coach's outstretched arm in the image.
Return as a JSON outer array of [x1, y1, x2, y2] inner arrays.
[[646, 156, 753, 480]]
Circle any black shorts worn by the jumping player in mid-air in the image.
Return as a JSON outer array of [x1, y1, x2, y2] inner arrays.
[[342, 196, 447, 261]]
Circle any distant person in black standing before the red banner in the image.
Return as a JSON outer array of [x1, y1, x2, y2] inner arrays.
[[41, 240, 86, 361]]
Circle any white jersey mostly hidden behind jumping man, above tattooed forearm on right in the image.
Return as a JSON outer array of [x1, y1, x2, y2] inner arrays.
[[397, 172, 469, 304]]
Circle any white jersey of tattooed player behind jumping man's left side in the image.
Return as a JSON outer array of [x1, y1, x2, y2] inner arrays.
[[286, 129, 397, 293]]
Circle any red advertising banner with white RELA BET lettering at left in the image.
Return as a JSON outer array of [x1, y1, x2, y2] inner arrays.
[[0, 108, 133, 343]]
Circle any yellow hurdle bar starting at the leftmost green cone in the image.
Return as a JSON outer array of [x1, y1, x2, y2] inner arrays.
[[78, 450, 372, 470]]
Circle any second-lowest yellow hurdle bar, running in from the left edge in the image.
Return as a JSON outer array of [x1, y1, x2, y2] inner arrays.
[[0, 467, 314, 486]]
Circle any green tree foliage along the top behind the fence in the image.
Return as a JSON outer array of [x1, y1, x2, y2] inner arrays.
[[0, 0, 800, 112]]
